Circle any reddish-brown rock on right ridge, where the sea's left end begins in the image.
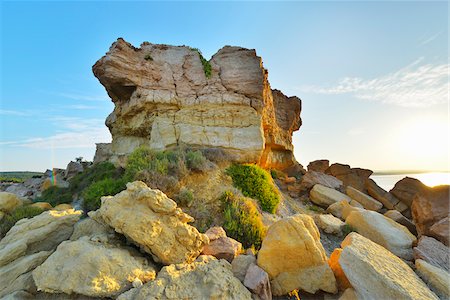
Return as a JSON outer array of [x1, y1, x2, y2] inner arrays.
[[325, 163, 373, 193]]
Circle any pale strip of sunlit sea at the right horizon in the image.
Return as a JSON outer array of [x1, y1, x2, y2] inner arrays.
[[370, 172, 450, 191]]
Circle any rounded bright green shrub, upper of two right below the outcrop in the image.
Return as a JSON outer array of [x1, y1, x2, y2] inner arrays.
[[226, 164, 280, 213]]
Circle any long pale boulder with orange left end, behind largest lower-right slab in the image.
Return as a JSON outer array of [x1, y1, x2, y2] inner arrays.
[[345, 210, 416, 260]]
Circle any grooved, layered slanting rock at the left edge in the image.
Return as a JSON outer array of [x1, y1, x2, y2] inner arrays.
[[0, 209, 81, 297]]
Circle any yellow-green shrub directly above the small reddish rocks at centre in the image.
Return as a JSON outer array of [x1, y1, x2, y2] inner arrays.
[[220, 192, 266, 249]]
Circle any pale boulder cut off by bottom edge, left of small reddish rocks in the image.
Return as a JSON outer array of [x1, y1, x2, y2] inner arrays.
[[133, 256, 251, 300]]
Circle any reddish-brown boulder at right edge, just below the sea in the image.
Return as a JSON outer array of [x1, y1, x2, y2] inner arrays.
[[411, 185, 450, 244]]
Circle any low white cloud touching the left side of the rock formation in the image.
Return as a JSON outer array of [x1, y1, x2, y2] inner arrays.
[[0, 116, 111, 149]]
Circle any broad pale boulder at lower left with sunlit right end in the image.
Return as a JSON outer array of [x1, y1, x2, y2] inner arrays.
[[33, 239, 156, 297]]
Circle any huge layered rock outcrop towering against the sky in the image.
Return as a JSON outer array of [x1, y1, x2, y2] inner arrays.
[[93, 39, 301, 168]]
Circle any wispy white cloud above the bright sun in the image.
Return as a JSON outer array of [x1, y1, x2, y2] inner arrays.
[[300, 59, 450, 107]]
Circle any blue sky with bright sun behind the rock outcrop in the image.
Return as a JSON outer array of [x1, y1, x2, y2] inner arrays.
[[0, 1, 450, 171]]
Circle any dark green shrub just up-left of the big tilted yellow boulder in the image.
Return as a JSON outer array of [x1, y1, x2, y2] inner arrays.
[[83, 178, 126, 211]]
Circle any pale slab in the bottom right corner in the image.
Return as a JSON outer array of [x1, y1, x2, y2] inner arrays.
[[416, 259, 450, 299]]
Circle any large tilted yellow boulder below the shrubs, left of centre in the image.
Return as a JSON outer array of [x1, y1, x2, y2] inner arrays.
[[98, 181, 209, 264]]
